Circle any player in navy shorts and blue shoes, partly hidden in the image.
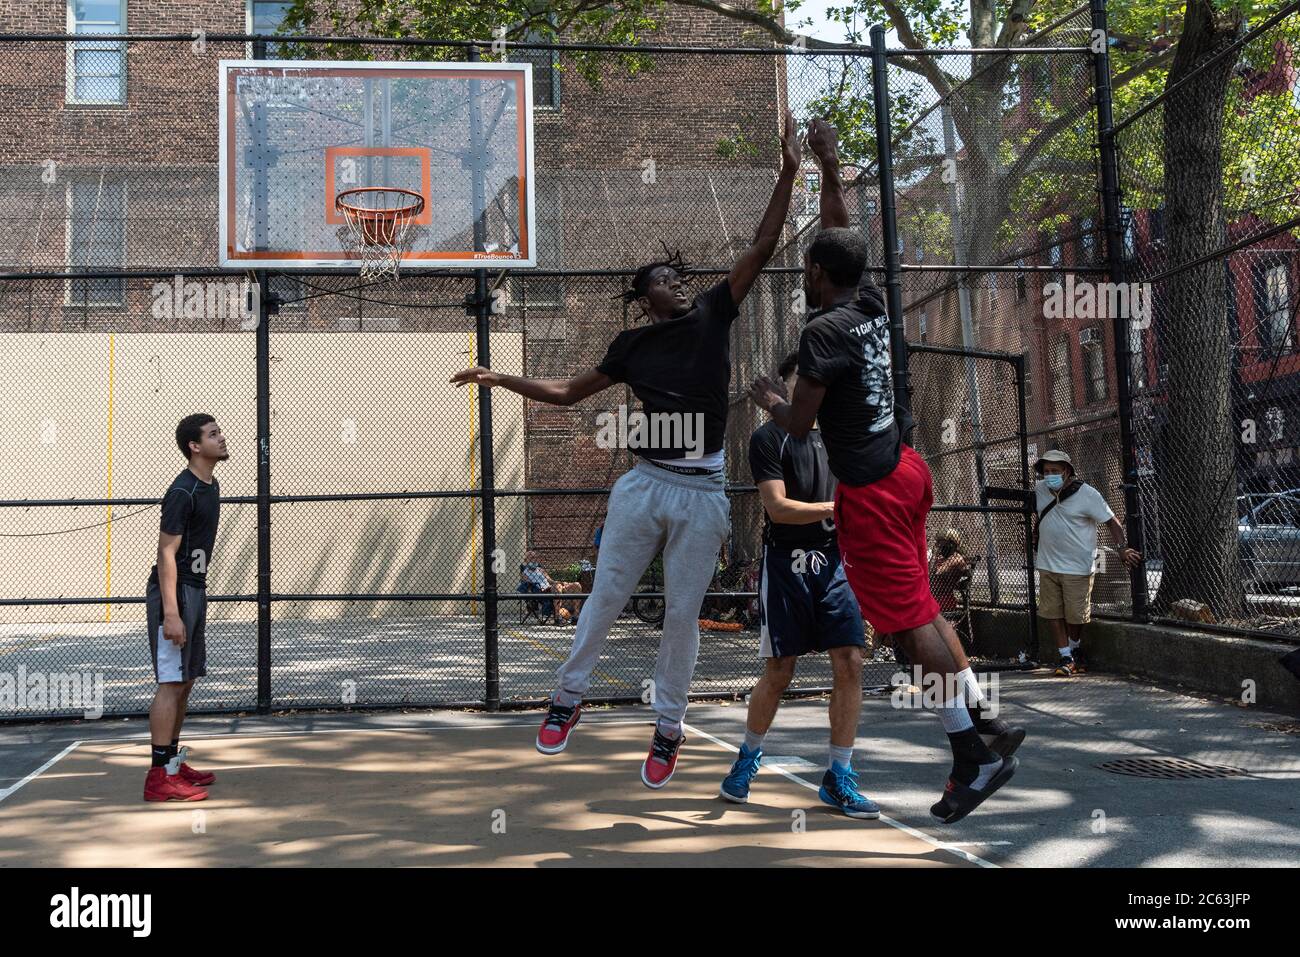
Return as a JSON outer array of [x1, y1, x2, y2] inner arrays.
[[720, 352, 880, 819]]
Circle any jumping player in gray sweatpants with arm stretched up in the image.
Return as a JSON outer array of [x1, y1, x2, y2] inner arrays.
[[451, 111, 802, 788]]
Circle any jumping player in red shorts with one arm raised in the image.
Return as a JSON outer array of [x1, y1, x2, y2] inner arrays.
[[751, 120, 1024, 824]]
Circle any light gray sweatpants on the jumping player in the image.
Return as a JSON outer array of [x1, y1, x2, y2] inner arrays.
[[559, 462, 731, 722]]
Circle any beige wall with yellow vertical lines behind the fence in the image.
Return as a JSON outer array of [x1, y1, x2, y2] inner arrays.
[[0, 332, 524, 623]]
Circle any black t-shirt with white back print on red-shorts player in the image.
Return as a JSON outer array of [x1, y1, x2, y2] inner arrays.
[[800, 277, 913, 485]]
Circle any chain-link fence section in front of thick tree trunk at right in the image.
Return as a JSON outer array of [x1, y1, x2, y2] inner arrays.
[[1115, 3, 1300, 637]]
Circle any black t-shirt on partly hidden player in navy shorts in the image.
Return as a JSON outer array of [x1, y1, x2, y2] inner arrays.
[[749, 423, 835, 549]]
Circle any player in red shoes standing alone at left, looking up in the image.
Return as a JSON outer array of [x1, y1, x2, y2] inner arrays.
[[144, 412, 230, 801]]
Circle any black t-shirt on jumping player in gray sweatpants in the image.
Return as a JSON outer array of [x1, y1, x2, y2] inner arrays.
[[595, 278, 740, 459]]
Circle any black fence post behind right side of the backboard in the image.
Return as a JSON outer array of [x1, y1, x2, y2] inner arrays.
[[465, 44, 501, 711]]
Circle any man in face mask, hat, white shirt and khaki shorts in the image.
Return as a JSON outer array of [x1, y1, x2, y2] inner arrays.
[[1034, 449, 1141, 677]]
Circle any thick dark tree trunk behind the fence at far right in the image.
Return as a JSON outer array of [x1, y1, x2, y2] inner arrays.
[[1135, 0, 1245, 619]]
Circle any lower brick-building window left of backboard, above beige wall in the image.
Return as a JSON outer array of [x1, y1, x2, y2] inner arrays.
[[68, 177, 126, 306]]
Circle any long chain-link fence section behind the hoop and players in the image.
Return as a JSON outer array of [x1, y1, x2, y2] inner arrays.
[[0, 8, 1113, 716]]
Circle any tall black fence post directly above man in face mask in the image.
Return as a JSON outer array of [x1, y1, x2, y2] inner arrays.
[[1091, 0, 1148, 622]]
